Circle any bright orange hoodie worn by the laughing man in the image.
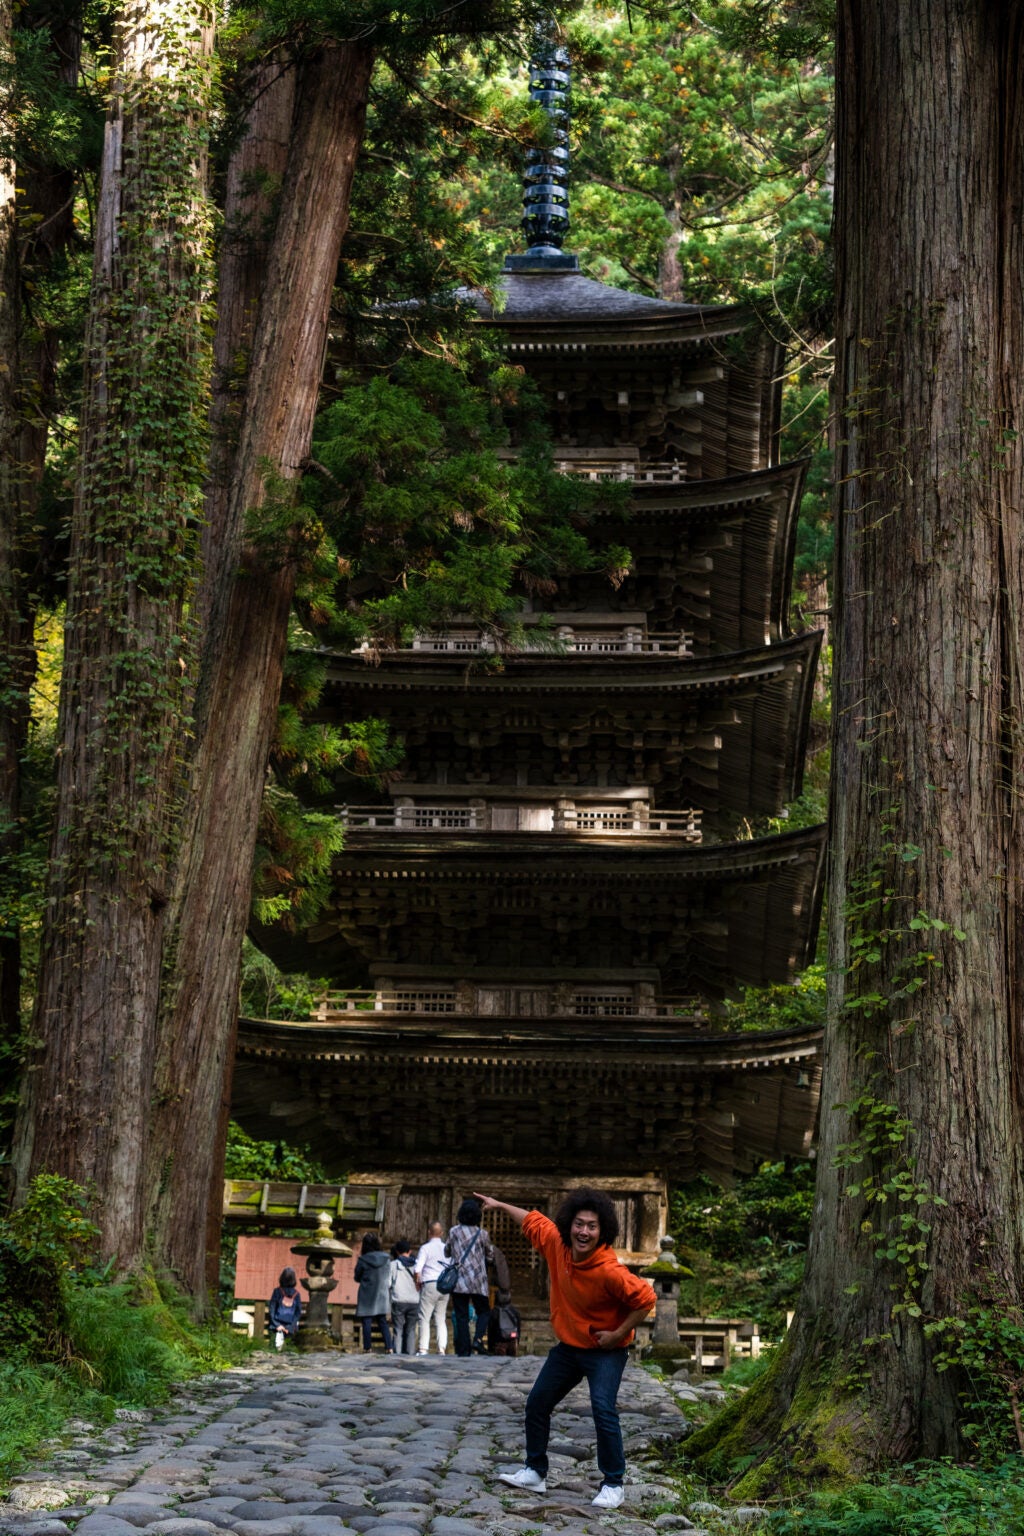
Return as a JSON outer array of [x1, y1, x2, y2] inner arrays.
[[522, 1210, 657, 1349]]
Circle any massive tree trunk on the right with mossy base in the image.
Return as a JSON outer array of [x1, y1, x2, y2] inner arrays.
[[695, 0, 1024, 1493]]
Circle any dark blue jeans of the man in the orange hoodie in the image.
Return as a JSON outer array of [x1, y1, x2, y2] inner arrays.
[[527, 1344, 629, 1488]]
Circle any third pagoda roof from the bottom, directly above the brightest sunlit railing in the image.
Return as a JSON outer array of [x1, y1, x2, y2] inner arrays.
[[316, 633, 821, 816]]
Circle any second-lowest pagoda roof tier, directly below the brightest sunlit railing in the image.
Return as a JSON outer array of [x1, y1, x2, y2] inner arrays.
[[253, 826, 824, 997]]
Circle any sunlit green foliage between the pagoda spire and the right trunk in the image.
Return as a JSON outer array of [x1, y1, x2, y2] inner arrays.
[[574, 8, 831, 335]]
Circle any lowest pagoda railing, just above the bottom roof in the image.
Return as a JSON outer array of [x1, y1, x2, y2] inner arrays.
[[308, 985, 703, 1025]]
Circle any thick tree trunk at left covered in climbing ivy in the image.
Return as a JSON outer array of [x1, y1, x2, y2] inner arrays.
[[15, 0, 212, 1269]]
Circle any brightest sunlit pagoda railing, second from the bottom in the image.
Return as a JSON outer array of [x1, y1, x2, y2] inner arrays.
[[336, 803, 702, 843]]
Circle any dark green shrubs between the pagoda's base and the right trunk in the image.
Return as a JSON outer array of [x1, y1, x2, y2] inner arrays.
[[669, 1163, 814, 1338]]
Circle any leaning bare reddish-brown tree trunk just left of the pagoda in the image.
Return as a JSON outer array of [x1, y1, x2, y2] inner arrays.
[[150, 43, 373, 1296]]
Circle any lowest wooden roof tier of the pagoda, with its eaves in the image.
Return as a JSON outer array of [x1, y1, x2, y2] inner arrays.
[[232, 1018, 821, 1181]]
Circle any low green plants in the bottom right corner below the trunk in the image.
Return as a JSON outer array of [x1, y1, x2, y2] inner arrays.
[[765, 1458, 1024, 1536]]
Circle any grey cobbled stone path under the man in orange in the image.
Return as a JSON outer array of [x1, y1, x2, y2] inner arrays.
[[0, 1352, 736, 1536]]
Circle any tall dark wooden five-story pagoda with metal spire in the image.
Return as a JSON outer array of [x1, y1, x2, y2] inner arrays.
[[235, 29, 824, 1250]]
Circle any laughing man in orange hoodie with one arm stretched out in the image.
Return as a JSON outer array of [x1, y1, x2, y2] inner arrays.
[[476, 1189, 657, 1510]]
